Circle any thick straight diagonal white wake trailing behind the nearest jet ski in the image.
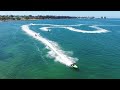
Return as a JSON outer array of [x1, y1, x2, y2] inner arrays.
[[21, 24, 78, 66]]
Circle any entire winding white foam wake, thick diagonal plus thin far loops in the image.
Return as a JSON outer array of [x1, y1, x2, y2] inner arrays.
[[21, 23, 109, 66]]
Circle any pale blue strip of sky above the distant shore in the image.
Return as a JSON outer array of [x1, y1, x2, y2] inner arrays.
[[0, 11, 120, 18]]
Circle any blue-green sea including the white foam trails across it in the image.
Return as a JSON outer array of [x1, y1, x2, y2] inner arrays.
[[0, 19, 120, 79]]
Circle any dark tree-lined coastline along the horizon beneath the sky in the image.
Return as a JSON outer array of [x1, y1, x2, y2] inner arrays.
[[0, 15, 106, 21]]
